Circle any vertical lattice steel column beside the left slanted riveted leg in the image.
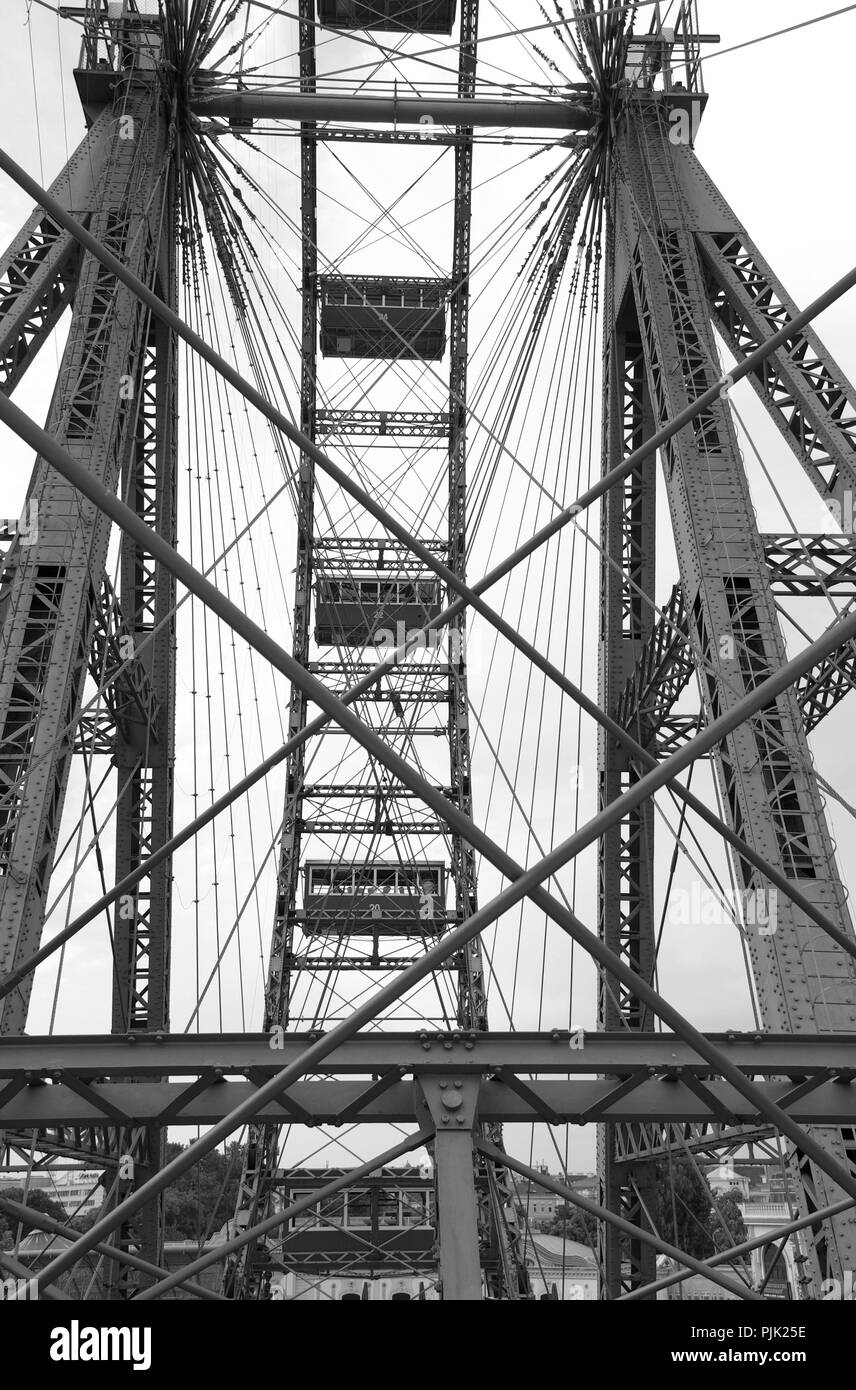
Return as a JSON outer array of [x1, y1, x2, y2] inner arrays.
[[111, 214, 178, 1297]]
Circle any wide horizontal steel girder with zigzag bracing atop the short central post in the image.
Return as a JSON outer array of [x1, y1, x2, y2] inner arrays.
[[6, 1031, 856, 1129]]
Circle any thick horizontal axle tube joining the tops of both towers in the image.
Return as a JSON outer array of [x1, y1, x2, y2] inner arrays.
[[190, 88, 595, 131]]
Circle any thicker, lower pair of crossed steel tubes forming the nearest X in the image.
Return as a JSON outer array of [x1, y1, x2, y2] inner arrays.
[[8, 372, 856, 1277]]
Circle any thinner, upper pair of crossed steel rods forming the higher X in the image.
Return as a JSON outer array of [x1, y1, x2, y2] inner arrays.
[[0, 150, 856, 998]]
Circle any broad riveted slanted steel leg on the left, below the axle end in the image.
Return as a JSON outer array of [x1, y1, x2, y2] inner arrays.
[[0, 79, 172, 1031]]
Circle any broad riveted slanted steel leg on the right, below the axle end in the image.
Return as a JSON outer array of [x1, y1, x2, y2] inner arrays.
[[616, 108, 856, 1276]]
